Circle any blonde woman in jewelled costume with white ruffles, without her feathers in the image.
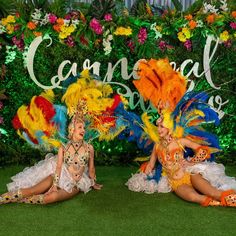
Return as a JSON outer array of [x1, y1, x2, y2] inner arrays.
[[0, 115, 102, 204]]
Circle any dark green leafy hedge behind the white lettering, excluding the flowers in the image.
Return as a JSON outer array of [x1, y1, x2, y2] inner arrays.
[[0, 0, 236, 165]]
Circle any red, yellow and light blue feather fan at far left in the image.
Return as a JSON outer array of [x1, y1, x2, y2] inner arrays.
[[12, 90, 66, 150]]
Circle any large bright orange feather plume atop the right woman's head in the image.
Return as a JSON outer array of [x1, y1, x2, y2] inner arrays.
[[133, 59, 187, 111]]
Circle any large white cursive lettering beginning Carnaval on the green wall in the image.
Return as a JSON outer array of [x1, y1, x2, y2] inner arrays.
[[26, 35, 229, 118]]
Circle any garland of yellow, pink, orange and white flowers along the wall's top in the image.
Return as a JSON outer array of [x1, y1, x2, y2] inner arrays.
[[0, 0, 236, 63]]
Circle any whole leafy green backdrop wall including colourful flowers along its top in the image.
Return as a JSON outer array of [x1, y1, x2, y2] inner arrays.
[[0, 0, 236, 165]]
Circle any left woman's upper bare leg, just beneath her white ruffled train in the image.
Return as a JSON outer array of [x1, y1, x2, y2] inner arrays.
[[21, 175, 53, 197]]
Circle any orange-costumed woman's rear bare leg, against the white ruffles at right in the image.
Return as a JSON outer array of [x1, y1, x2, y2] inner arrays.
[[191, 174, 222, 201]]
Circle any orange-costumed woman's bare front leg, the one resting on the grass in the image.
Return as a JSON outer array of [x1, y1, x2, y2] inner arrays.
[[175, 184, 206, 204]]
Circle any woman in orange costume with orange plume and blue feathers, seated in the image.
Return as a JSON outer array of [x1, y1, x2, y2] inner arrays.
[[126, 59, 236, 207]]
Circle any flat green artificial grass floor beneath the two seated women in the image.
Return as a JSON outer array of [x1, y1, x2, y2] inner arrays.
[[0, 166, 236, 236]]
